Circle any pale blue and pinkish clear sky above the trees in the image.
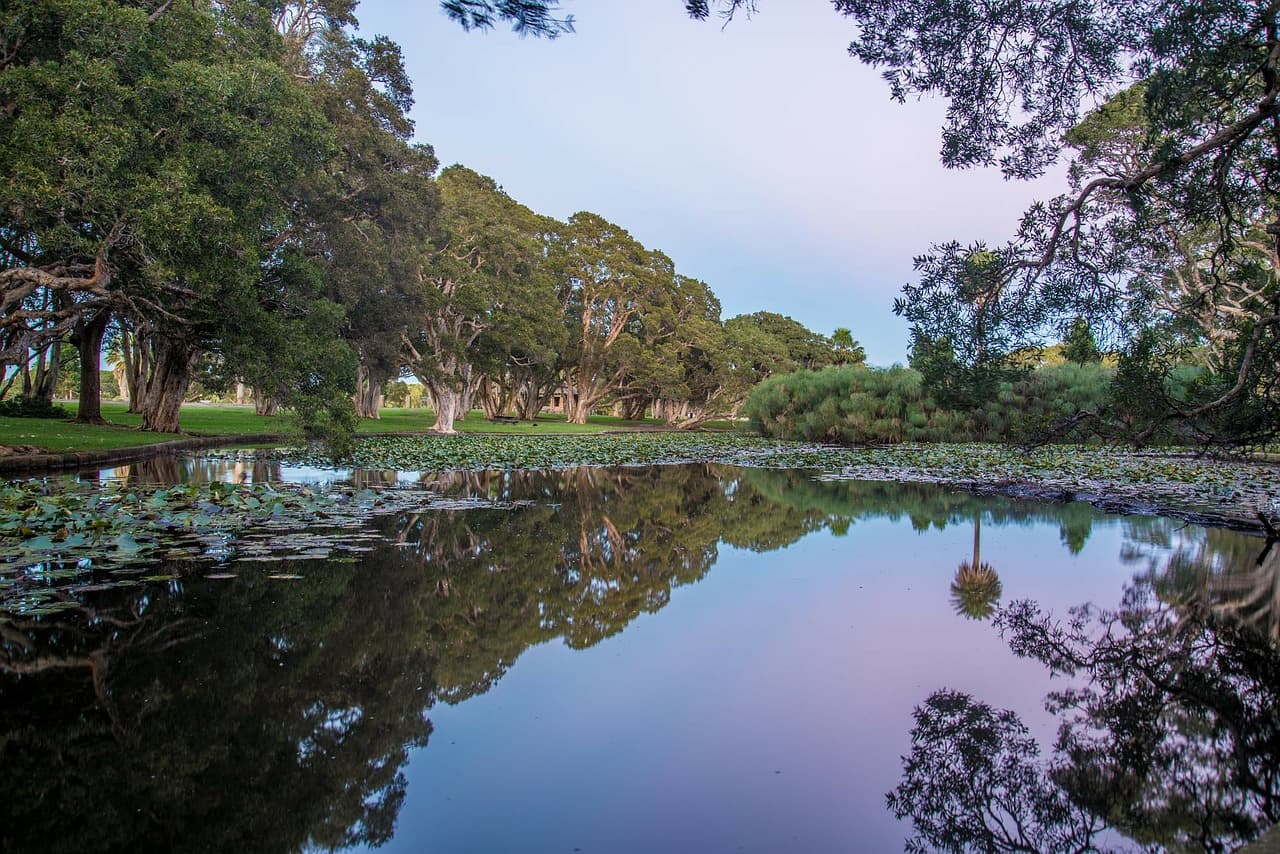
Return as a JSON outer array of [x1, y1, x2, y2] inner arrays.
[[357, 0, 1060, 365]]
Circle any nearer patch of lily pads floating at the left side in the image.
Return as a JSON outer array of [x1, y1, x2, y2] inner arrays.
[[0, 478, 520, 613]]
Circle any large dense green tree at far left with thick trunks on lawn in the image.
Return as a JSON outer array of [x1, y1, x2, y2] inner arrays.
[[0, 0, 337, 431]]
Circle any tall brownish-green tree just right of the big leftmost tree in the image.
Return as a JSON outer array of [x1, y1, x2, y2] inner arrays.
[[274, 3, 439, 417]]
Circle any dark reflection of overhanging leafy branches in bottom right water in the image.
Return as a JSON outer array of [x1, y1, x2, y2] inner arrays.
[[890, 536, 1280, 851]]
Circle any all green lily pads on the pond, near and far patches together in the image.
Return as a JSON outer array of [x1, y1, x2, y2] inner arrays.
[[0, 433, 1280, 613]]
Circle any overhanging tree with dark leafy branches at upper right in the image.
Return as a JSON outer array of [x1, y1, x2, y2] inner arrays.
[[686, 0, 1280, 444]]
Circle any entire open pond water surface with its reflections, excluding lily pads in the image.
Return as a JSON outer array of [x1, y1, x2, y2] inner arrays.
[[0, 457, 1280, 851]]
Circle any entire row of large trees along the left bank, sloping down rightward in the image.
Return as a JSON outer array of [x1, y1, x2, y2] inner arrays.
[[0, 0, 861, 448]]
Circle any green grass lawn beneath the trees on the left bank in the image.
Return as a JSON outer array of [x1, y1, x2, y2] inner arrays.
[[0, 402, 662, 452]]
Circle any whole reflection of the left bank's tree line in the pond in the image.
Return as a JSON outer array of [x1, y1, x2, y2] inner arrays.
[[0, 463, 1187, 851]]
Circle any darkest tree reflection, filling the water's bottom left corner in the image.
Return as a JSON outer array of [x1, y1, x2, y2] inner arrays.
[[0, 562, 430, 851]]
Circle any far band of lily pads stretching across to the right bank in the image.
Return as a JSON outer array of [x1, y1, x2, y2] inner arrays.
[[283, 433, 1280, 529]]
